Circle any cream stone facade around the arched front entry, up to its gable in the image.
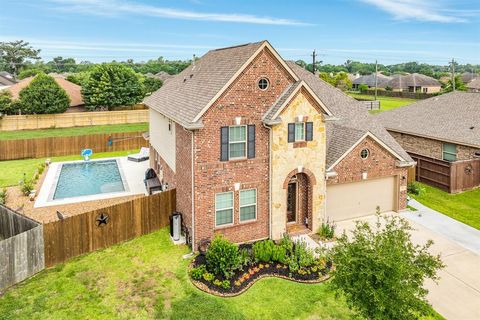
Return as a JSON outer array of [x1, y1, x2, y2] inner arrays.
[[271, 90, 326, 239]]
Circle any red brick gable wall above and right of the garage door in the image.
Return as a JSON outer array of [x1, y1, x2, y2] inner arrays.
[[327, 137, 408, 210]]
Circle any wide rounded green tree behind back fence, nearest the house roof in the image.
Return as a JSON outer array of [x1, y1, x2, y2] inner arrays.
[[82, 63, 144, 110]]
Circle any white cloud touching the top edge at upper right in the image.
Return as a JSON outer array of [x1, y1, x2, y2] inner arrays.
[[360, 0, 467, 23]]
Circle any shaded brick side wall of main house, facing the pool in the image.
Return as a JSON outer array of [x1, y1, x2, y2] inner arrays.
[[150, 123, 193, 238]]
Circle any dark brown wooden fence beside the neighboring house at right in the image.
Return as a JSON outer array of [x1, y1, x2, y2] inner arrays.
[[410, 154, 480, 193]]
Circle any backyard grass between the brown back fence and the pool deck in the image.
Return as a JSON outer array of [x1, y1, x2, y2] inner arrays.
[[0, 150, 138, 188]]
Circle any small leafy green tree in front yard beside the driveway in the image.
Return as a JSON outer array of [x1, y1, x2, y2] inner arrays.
[[331, 216, 443, 320]]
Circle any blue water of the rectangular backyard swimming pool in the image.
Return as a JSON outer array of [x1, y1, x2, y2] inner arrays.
[[53, 160, 125, 199]]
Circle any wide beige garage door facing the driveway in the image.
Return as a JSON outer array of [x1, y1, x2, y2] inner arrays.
[[327, 177, 397, 221]]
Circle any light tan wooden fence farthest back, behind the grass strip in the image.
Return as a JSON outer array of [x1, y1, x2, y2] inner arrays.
[[0, 110, 148, 131]]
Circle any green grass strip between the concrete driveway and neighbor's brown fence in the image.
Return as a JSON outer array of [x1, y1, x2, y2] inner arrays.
[[412, 184, 480, 230]]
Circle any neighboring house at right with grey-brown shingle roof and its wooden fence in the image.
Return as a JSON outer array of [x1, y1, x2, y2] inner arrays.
[[378, 91, 480, 192]]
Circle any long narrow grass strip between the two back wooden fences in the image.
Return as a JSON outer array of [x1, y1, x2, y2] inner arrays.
[[0, 123, 148, 140]]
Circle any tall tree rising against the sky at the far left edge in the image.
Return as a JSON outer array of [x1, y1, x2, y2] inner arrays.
[[0, 40, 40, 78]]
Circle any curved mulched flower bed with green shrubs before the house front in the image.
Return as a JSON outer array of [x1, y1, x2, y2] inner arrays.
[[189, 236, 332, 297]]
